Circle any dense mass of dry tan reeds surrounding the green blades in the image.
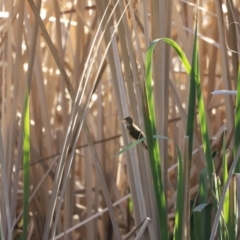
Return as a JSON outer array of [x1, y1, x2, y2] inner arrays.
[[0, 0, 240, 240]]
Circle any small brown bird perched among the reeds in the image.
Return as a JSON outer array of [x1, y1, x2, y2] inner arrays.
[[121, 117, 148, 149]]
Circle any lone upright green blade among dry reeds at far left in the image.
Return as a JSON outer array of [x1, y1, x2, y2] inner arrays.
[[22, 90, 30, 239]]
